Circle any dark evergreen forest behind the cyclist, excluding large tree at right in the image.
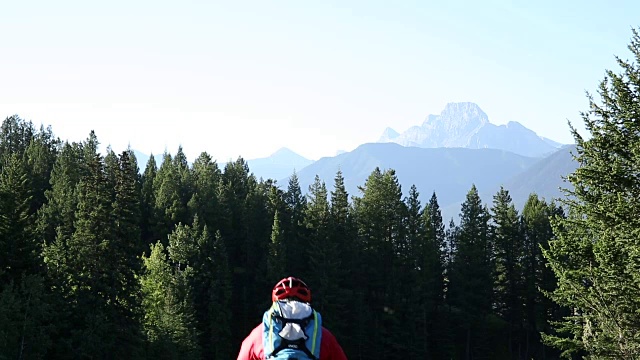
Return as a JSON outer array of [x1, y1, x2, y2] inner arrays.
[[0, 116, 563, 359]]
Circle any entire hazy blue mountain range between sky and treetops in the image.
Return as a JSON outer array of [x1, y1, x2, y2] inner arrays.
[[136, 103, 577, 220]]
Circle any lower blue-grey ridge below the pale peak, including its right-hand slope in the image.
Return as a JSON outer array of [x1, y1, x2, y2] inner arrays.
[[277, 143, 577, 221]]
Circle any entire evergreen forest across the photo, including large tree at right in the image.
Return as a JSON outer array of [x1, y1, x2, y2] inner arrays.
[[0, 31, 640, 359]]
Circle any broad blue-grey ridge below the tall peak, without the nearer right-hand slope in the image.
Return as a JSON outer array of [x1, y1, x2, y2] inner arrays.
[[278, 143, 538, 219]]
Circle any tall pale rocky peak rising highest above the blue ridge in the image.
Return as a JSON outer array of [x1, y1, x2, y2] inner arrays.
[[378, 102, 558, 157]]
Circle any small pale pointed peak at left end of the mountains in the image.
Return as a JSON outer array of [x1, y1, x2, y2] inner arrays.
[[245, 148, 313, 180]]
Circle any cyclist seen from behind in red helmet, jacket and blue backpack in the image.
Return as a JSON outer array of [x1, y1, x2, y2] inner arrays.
[[237, 277, 347, 360]]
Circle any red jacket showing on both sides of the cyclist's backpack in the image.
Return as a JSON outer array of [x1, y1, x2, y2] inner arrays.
[[238, 324, 347, 360]]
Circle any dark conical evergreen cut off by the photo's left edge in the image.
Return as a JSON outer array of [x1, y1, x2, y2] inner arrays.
[[0, 143, 51, 359]]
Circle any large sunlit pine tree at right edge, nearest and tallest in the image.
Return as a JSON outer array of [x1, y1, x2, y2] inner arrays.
[[545, 29, 640, 359]]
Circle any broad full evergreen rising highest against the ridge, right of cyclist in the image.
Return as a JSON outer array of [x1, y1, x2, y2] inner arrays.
[[354, 168, 409, 357]]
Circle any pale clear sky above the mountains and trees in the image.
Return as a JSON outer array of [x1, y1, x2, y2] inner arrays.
[[0, 0, 640, 162]]
